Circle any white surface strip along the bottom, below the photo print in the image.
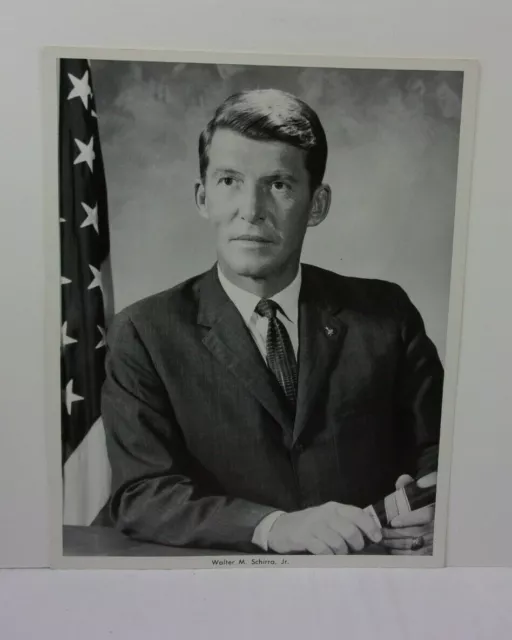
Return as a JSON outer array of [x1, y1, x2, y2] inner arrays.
[[0, 569, 512, 640]]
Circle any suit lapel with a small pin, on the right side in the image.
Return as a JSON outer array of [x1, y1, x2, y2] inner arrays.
[[293, 265, 347, 442]]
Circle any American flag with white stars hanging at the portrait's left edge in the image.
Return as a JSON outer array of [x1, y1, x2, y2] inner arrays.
[[59, 59, 110, 525]]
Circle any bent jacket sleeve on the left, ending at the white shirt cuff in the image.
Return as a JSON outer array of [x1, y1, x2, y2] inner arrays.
[[102, 313, 275, 552]]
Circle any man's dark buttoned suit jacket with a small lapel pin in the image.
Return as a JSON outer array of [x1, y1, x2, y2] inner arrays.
[[102, 265, 443, 551]]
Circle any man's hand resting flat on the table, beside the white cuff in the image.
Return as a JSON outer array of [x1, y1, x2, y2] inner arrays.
[[268, 502, 382, 554]]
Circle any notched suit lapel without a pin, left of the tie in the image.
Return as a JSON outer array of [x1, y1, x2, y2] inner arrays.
[[198, 266, 293, 430]]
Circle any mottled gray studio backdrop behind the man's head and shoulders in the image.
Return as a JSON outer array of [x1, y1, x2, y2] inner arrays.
[[92, 61, 462, 359]]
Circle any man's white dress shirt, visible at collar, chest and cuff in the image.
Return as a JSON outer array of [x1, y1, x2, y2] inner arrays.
[[217, 267, 302, 551]]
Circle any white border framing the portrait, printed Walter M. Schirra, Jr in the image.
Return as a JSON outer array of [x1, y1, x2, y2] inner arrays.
[[41, 47, 479, 569]]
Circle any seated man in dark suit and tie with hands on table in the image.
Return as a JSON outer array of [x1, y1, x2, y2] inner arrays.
[[103, 90, 443, 554]]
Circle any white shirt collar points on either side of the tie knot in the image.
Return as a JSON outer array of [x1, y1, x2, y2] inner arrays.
[[217, 265, 302, 324]]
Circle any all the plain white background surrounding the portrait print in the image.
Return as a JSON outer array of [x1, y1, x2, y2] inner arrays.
[[0, 0, 512, 640]]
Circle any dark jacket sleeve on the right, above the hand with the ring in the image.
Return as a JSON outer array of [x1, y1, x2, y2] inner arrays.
[[397, 289, 444, 477]]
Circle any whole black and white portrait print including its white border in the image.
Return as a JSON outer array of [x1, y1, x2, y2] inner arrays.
[[44, 49, 476, 568]]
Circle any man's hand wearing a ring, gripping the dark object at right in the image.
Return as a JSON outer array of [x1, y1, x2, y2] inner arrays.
[[381, 473, 437, 556]]
